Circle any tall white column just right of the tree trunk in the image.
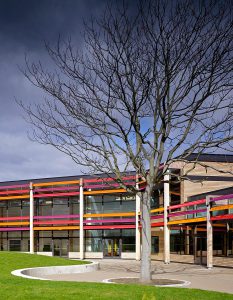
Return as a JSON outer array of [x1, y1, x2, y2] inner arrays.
[[163, 174, 170, 264]]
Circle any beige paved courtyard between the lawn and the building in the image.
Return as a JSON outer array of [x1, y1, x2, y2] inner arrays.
[[39, 259, 233, 294]]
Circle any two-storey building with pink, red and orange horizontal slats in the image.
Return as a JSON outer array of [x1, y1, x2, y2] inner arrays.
[[0, 154, 233, 267]]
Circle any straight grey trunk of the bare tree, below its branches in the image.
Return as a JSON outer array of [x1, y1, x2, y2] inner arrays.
[[140, 185, 151, 283]]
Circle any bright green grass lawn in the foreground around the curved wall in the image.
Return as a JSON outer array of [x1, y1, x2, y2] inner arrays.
[[0, 252, 233, 300]]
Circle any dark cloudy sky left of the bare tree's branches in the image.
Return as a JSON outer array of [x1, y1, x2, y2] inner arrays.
[[0, 0, 108, 181]]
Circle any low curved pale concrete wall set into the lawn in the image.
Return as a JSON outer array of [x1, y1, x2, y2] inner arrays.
[[11, 262, 99, 280]]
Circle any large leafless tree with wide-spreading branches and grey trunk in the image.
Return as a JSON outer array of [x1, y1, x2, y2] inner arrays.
[[21, 0, 233, 282]]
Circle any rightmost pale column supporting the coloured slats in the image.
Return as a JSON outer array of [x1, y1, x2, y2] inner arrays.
[[206, 196, 213, 269]]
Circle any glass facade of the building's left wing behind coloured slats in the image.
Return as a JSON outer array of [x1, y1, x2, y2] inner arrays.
[[0, 194, 135, 256]]
